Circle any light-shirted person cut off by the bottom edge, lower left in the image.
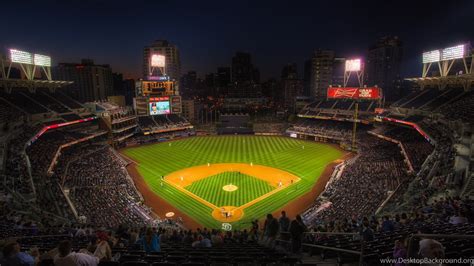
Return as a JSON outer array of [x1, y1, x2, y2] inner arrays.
[[54, 240, 99, 266]]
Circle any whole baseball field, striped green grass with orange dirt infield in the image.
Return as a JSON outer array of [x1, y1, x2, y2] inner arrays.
[[121, 136, 343, 228]]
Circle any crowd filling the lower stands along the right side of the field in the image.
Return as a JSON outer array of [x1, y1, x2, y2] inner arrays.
[[303, 134, 409, 224]]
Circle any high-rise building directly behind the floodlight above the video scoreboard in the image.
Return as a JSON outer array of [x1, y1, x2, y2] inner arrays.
[[143, 40, 181, 81]]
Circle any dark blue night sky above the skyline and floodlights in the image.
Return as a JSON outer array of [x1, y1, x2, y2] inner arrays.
[[0, 0, 474, 79]]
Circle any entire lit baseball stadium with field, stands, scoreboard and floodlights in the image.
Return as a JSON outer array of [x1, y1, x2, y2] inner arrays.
[[0, 25, 474, 266]]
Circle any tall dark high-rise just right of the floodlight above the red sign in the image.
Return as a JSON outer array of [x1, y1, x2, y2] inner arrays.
[[365, 36, 403, 101]]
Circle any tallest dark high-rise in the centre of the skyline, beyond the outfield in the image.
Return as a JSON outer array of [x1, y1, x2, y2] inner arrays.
[[232, 52, 260, 83]]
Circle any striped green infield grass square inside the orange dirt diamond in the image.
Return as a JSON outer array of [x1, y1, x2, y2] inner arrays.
[[185, 172, 275, 207]]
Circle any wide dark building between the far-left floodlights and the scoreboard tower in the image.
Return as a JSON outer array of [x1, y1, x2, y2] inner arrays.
[[53, 59, 114, 102]]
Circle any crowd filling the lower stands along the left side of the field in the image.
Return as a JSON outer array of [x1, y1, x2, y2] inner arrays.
[[64, 147, 151, 227]]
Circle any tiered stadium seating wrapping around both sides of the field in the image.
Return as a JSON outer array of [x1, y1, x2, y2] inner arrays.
[[0, 88, 474, 265]]
